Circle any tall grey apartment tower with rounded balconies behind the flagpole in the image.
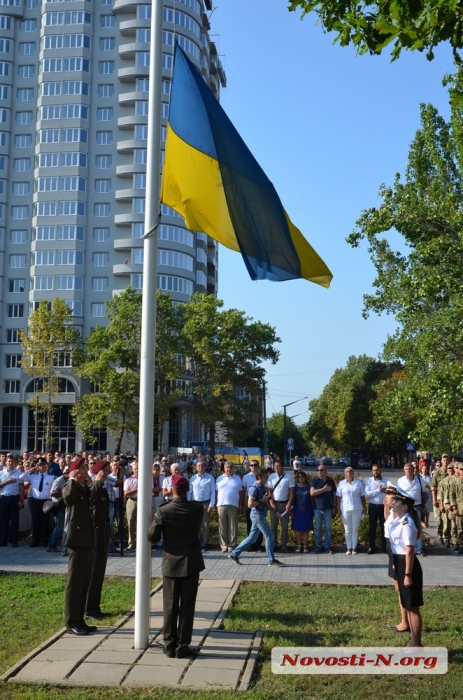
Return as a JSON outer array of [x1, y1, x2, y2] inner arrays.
[[0, 0, 225, 451]]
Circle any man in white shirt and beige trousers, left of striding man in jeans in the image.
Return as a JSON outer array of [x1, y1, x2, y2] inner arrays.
[[215, 462, 244, 552]]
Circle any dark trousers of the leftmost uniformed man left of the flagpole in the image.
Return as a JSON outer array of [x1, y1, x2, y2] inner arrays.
[[64, 545, 95, 628]]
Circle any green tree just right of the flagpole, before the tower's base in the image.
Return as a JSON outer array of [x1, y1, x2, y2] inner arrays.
[[182, 293, 280, 452]]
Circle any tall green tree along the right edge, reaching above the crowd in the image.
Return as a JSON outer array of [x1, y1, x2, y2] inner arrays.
[[348, 73, 463, 450]]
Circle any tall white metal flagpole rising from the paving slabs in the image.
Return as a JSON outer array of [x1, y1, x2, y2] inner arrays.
[[134, 0, 164, 649]]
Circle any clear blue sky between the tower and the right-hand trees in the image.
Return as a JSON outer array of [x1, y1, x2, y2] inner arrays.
[[211, 0, 453, 423]]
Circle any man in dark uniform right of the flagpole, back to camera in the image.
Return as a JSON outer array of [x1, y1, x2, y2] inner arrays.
[[148, 474, 204, 659]]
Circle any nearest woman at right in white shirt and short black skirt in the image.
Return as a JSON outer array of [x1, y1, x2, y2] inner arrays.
[[388, 489, 423, 647]]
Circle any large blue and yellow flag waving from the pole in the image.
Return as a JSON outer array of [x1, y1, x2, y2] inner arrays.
[[161, 44, 332, 287]]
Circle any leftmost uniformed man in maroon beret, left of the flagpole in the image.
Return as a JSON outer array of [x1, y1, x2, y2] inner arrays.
[[62, 457, 96, 636]]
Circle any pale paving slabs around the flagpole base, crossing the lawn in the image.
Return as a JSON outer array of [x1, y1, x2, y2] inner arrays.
[[0, 579, 261, 695]]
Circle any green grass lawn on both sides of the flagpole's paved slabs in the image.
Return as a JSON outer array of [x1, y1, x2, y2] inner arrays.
[[0, 575, 463, 700]]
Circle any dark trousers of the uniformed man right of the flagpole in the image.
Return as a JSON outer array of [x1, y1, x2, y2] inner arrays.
[[162, 573, 199, 651]]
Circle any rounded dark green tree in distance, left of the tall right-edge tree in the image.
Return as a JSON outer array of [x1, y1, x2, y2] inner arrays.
[[307, 355, 397, 456]]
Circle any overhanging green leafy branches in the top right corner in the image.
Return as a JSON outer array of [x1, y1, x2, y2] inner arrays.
[[288, 0, 463, 60]]
